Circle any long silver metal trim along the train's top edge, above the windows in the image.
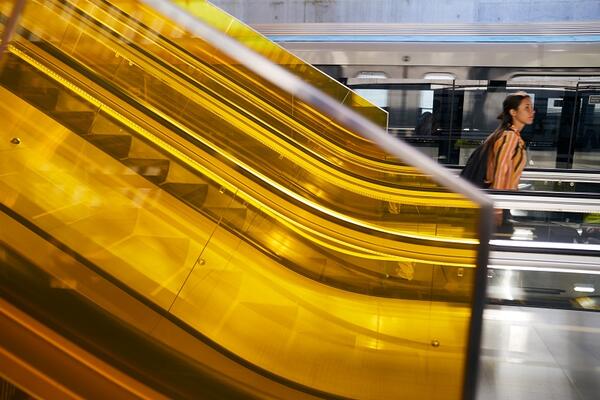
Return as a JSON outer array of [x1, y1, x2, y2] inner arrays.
[[268, 38, 600, 72]]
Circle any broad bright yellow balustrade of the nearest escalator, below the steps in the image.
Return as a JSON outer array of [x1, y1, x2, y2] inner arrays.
[[2, 86, 478, 398]]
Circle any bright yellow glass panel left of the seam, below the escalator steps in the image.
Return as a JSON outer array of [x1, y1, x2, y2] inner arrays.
[[0, 89, 213, 307]]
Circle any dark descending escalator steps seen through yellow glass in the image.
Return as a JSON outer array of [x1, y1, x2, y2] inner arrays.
[[0, 43, 468, 298]]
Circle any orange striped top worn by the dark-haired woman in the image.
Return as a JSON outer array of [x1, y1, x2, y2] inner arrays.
[[486, 130, 527, 190]]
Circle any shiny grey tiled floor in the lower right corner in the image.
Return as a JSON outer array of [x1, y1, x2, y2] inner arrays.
[[477, 306, 600, 400]]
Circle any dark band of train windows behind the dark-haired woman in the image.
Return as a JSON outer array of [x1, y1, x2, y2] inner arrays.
[[349, 73, 600, 169]]
